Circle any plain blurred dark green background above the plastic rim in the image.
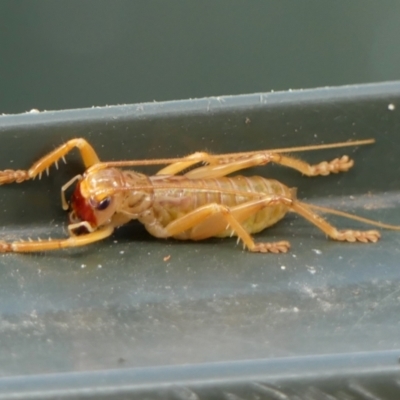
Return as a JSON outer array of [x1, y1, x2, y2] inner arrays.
[[0, 0, 400, 113]]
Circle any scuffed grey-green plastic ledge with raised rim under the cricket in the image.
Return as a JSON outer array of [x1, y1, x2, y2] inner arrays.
[[0, 82, 400, 399]]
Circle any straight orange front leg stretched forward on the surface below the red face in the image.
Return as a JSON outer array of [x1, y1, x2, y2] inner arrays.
[[0, 225, 114, 253]]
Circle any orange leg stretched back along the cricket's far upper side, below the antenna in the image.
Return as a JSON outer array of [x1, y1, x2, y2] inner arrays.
[[157, 151, 354, 179]]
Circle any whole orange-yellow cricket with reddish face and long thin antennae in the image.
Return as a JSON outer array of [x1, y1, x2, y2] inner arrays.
[[0, 138, 400, 253]]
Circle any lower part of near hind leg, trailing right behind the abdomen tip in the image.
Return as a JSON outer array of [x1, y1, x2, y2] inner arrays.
[[290, 200, 381, 243]]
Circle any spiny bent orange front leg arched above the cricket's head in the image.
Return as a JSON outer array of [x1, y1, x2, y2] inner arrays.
[[0, 138, 99, 185]]
